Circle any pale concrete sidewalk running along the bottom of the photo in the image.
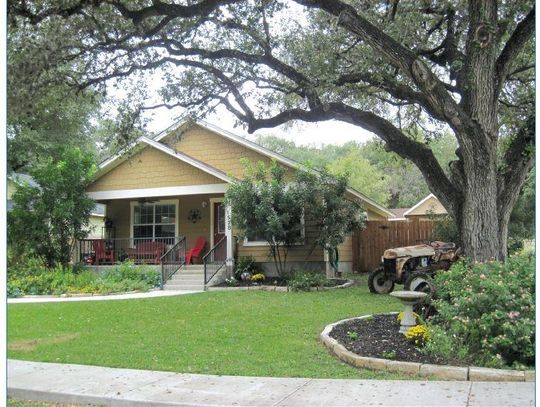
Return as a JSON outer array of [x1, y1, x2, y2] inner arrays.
[[8, 360, 535, 407]]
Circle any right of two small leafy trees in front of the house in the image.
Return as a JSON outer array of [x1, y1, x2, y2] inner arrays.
[[297, 170, 366, 274]]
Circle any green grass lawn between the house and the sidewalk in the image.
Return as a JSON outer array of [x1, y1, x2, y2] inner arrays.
[[8, 285, 407, 379]]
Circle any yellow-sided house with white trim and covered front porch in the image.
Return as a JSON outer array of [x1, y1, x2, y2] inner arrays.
[[81, 120, 393, 283]]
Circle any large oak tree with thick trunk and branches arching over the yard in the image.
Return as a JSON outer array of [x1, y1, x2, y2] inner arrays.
[[8, 0, 535, 261]]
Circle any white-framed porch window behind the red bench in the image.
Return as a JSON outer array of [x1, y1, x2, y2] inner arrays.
[[132, 202, 177, 240]]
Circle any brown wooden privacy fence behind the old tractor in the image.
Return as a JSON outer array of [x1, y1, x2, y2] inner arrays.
[[353, 218, 433, 272]]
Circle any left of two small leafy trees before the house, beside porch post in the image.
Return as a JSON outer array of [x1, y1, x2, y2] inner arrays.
[[225, 161, 304, 276]]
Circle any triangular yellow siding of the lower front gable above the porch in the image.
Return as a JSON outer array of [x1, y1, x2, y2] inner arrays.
[[87, 147, 223, 192]]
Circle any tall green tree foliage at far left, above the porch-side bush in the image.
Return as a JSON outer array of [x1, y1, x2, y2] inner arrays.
[[7, 13, 103, 172]]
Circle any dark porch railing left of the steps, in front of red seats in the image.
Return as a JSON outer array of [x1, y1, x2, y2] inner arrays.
[[76, 236, 182, 266]]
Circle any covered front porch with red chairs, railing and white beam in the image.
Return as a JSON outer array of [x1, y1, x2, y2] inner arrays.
[[75, 184, 234, 283]]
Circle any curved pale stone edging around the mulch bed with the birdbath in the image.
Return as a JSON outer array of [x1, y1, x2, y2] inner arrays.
[[320, 312, 535, 382]]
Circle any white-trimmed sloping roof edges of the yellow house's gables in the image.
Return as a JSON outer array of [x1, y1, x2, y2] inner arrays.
[[96, 118, 395, 218]]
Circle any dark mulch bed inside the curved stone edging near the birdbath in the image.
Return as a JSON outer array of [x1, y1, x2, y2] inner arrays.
[[330, 315, 464, 365]]
